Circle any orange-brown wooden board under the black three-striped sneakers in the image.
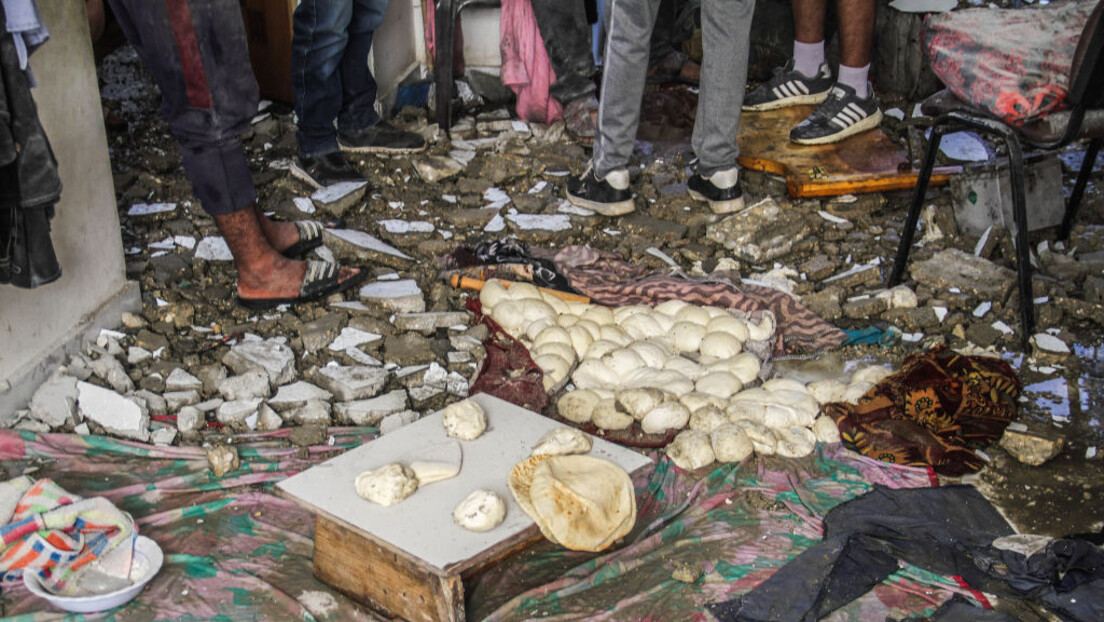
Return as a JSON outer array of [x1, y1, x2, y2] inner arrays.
[[737, 106, 952, 198]]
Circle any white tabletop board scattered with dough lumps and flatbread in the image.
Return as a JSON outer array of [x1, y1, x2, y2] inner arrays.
[[277, 393, 651, 570]]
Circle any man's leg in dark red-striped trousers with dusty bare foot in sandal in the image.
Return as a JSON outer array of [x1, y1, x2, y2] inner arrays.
[[109, 0, 357, 297]]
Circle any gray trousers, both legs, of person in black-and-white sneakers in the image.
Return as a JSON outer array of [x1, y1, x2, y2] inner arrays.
[[593, 0, 755, 179]]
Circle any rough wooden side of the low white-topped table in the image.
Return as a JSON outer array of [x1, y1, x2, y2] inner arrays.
[[315, 514, 465, 622]]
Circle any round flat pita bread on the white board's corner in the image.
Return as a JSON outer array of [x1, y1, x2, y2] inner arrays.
[[510, 455, 636, 551]]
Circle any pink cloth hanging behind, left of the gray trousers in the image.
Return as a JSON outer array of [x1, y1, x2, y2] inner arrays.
[[499, 0, 563, 123]]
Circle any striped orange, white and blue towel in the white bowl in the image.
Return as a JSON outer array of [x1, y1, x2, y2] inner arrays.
[[0, 476, 137, 594]]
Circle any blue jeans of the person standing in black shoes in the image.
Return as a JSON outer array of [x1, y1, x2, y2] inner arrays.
[[291, 0, 388, 158]]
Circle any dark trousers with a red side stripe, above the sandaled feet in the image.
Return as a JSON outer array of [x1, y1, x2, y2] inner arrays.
[[108, 0, 257, 215]]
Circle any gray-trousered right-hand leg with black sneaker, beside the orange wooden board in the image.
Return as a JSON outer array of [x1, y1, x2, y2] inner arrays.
[[688, 0, 755, 213]]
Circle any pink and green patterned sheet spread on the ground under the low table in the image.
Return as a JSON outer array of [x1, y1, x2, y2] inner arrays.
[[0, 428, 980, 621]]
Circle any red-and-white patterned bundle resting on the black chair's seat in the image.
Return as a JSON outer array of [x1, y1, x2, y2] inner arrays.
[[923, 0, 1096, 126]]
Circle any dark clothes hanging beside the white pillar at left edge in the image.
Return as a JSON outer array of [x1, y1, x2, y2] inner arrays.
[[0, 0, 62, 288]]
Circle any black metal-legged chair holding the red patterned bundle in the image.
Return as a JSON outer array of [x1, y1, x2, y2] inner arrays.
[[889, 0, 1104, 351]]
